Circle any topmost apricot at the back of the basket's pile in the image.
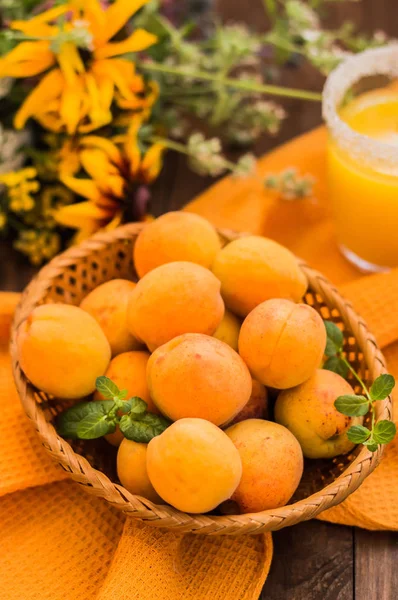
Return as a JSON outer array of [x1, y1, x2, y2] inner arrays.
[[134, 212, 221, 277]]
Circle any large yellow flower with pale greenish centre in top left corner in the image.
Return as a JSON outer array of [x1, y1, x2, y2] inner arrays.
[[0, 0, 157, 134]]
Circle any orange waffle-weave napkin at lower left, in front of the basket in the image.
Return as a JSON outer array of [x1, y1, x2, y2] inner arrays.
[[0, 293, 272, 600]]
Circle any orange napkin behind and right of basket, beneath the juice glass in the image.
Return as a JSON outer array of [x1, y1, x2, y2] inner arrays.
[[186, 127, 398, 530]]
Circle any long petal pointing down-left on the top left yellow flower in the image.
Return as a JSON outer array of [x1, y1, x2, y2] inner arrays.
[[14, 69, 65, 129]]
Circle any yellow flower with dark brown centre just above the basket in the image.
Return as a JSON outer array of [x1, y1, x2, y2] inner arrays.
[[54, 115, 164, 242]]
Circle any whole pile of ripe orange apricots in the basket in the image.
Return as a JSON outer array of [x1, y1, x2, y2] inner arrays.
[[18, 212, 354, 513]]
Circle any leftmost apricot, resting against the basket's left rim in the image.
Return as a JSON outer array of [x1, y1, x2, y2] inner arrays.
[[17, 304, 111, 398]]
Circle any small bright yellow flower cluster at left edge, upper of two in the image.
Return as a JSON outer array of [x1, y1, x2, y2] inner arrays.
[[0, 167, 40, 212]]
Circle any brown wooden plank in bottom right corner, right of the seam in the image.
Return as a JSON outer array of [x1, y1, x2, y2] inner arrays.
[[354, 529, 398, 600]]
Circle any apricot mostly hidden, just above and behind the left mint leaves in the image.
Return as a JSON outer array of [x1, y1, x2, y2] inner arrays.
[[94, 350, 159, 446]]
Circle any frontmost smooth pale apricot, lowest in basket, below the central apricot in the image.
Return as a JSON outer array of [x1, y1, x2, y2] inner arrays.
[[147, 419, 242, 513]]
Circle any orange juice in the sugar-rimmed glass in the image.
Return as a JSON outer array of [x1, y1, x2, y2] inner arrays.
[[328, 84, 398, 271]]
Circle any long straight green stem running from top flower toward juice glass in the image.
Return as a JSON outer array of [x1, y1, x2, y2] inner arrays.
[[138, 61, 322, 102]]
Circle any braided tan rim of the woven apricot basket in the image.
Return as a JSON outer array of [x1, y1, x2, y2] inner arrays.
[[10, 223, 392, 535]]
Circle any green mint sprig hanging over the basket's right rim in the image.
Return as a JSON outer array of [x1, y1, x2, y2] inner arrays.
[[323, 321, 396, 452]]
